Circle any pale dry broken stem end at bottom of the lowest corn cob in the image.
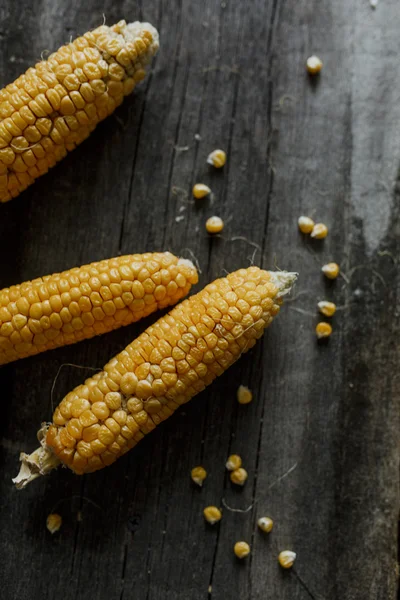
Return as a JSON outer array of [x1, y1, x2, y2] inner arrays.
[[12, 423, 60, 490]]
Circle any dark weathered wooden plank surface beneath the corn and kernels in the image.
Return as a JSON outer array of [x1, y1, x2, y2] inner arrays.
[[0, 0, 400, 600]]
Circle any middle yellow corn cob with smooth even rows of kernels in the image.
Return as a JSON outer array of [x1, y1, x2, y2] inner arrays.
[[0, 252, 198, 365]]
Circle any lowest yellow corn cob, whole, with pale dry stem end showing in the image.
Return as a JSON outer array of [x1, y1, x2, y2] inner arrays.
[[14, 267, 296, 488]]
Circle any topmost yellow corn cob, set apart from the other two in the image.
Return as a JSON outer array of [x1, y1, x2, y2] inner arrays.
[[0, 21, 159, 202]]
